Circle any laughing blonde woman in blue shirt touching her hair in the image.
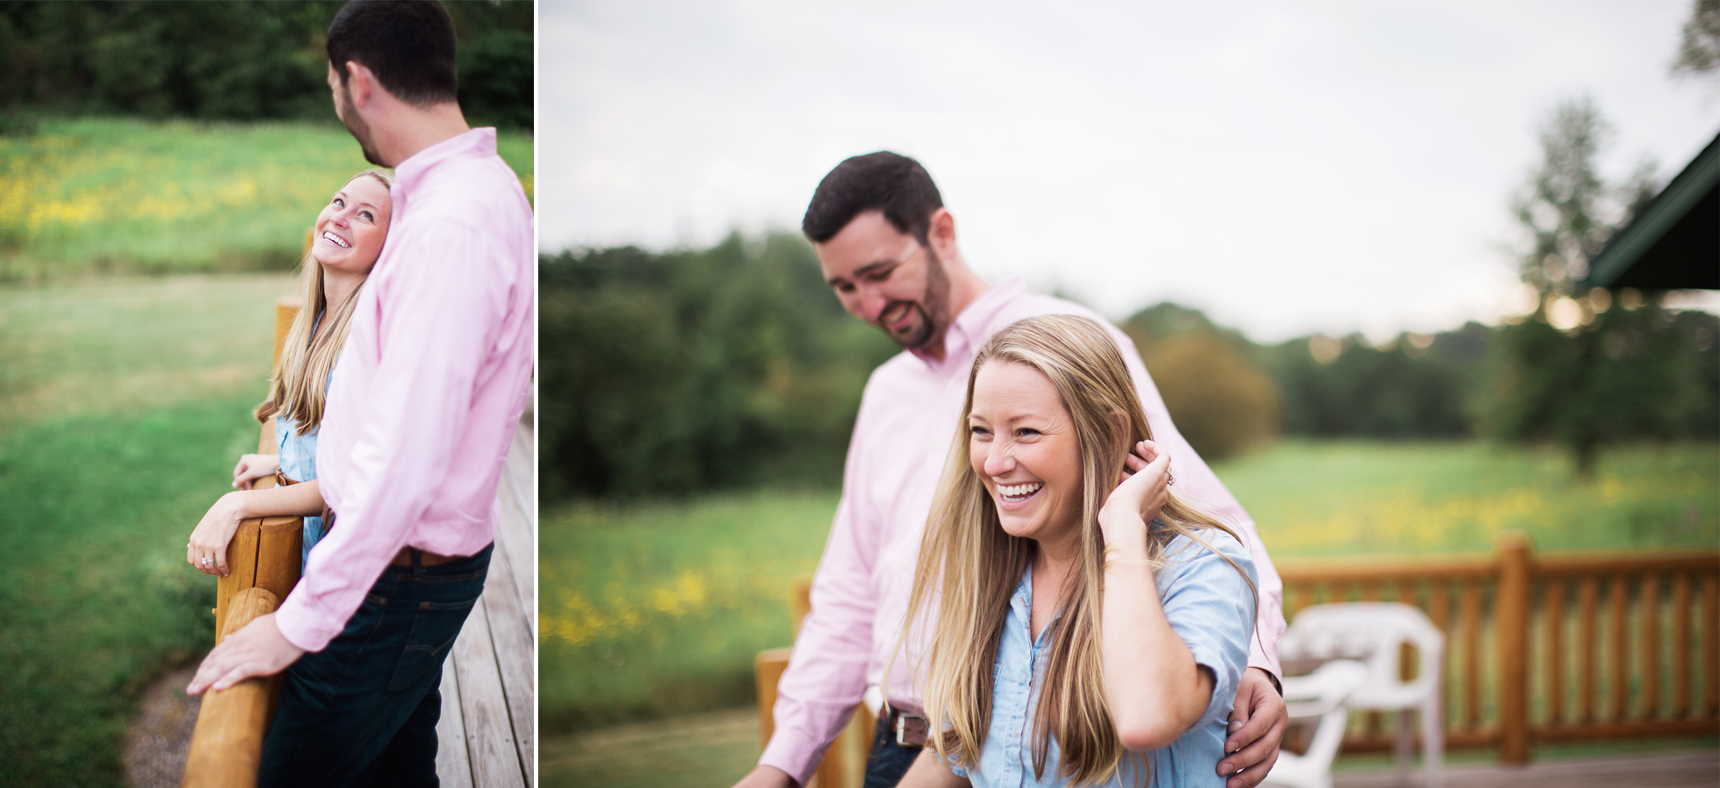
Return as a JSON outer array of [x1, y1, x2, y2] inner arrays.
[[901, 315, 1256, 786]]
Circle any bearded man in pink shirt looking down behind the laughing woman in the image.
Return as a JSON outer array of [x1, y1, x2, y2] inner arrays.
[[740, 151, 1288, 788]]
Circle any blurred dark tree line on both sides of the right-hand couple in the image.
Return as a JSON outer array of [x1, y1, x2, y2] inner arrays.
[[540, 234, 1720, 501]]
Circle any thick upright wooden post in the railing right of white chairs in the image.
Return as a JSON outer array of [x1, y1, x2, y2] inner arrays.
[[1495, 532, 1531, 764]]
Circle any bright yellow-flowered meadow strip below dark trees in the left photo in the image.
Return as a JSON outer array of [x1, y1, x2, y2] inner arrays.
[[0, 119, 533, 282]]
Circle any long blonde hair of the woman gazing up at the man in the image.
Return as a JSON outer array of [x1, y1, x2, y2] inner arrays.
[[251, 169, 394, 435]]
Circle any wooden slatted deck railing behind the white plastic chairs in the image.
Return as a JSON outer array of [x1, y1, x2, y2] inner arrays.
[[1278, 533, 1720, 764]]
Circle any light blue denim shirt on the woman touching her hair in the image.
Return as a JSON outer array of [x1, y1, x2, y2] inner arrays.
[[951, 530, 1254, 788]]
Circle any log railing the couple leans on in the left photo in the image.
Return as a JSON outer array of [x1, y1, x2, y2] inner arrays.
[[181, 298, 304, 788]]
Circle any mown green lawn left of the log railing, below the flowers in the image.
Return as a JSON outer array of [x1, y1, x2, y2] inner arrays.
[[0, 274, 292, 786]]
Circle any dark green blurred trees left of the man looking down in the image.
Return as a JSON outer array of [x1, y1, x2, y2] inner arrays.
[[538, 234, 896, 499]]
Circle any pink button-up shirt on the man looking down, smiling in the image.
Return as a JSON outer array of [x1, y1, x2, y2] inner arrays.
[[759, 280, 1285, 785]]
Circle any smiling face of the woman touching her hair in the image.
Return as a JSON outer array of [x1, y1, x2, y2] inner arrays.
[[968, 361, 1082, 542]]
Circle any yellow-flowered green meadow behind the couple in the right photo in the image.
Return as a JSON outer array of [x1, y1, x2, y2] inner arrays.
[[538, 442, 1720, 731]]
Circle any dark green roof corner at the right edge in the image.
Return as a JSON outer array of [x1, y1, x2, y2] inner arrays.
[[1588, 127, 1720, 291]]
